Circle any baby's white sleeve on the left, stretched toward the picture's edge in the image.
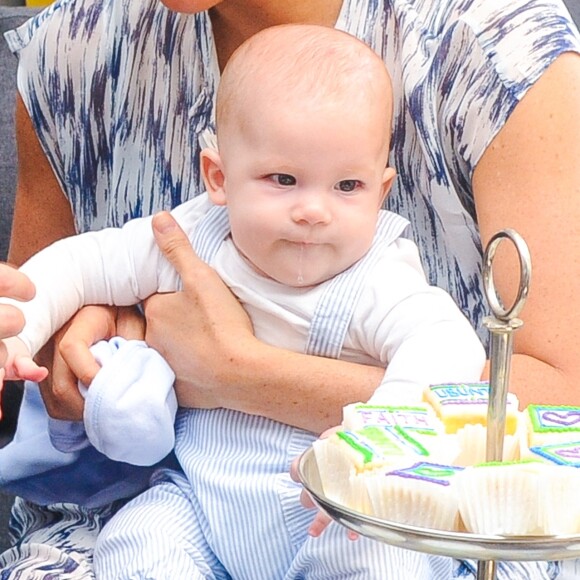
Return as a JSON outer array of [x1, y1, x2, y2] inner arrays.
[[1, 198, 211, 355]]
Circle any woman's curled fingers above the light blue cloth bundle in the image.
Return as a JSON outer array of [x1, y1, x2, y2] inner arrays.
[[38, 306, 145, 421]]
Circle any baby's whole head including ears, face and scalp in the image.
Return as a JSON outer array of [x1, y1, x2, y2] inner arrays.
[[202, 25, 395, 286]]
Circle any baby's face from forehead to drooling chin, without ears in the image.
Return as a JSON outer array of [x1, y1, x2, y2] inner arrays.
[[220, 103, 394, 287]]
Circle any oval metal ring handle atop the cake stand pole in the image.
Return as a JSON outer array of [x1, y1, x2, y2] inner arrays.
[[483, 229, 532, 322]]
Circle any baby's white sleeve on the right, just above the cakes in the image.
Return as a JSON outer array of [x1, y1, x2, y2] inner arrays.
[[359, 240, 486, 403]]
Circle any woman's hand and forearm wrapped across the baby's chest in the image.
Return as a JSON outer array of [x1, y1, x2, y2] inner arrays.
[[145, 212, 385, 433]]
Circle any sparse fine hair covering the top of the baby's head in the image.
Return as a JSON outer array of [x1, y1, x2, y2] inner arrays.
[[217, 25, 392, 152]]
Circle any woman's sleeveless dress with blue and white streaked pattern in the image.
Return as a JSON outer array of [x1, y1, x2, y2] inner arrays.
[[0, 0, 580, 578]]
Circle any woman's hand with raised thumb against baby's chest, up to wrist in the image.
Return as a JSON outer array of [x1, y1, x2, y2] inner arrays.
[[144, 212, 257, 409]]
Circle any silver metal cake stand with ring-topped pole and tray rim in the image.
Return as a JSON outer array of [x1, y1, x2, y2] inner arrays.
[[298, 229, 580, 580]]
